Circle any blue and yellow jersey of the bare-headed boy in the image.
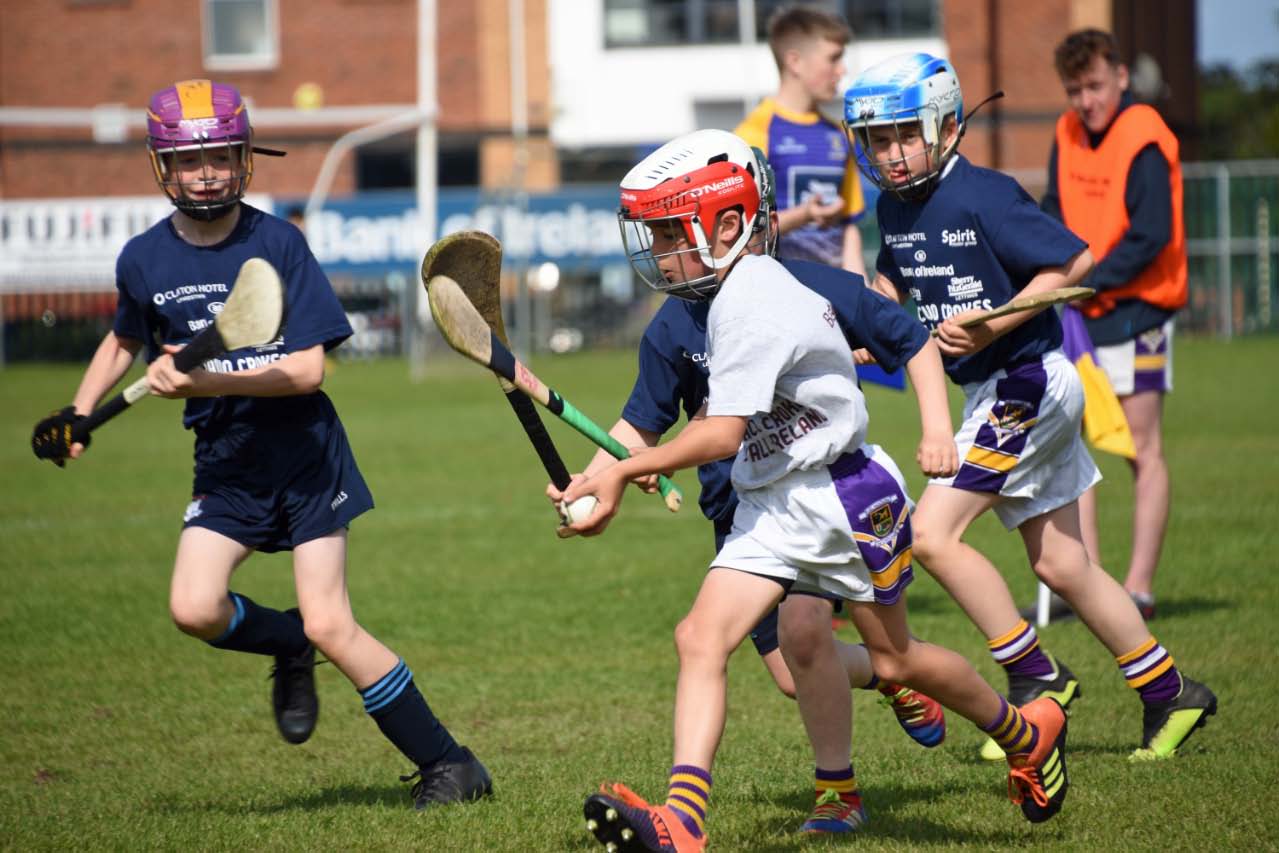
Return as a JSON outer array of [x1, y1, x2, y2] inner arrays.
[[734, 98, 866, 266]]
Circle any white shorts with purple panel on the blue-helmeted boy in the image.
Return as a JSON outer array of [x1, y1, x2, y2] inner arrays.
[[930, 350, 1101, 529]]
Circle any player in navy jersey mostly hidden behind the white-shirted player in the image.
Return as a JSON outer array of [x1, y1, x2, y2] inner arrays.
[[546, 132, 945, 831]]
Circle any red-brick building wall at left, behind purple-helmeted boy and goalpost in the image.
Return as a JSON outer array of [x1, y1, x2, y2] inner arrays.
[[0, 0, 550, 198]]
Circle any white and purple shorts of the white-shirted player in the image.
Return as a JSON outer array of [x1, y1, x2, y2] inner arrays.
[[711, 444, 914, 605]]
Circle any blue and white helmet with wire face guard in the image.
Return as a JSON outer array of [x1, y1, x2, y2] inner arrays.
[[844, 54, 964, 200]]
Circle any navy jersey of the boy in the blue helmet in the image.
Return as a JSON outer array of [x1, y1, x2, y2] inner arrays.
[[875, 156, 1087, 385]]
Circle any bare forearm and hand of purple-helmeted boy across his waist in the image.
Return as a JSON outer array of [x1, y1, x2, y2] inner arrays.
[[147, 344, 324, 399]]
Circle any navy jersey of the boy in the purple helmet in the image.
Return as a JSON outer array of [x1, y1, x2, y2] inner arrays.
[[114, 203, 352, 435]]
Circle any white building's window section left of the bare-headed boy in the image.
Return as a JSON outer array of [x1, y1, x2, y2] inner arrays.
[[604, 0, 739, 47]]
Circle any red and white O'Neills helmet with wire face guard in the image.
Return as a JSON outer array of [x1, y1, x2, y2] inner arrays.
[[618, 130, 774, 302]]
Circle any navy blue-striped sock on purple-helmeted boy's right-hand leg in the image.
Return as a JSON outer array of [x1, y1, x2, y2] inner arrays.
[[359, 660, 466, 767]]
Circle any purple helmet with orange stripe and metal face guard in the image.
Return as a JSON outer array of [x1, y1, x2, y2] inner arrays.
[[147, 79, 253, 221]]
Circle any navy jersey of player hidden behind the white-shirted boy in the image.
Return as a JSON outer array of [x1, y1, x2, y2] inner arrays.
[[622, 260, 929, 520]]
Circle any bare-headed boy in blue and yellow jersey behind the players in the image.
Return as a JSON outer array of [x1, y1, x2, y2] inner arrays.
[[735, 6, 866, 276]]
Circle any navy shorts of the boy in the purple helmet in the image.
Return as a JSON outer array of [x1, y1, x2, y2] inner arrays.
[[183, 394, 373, 552]]
